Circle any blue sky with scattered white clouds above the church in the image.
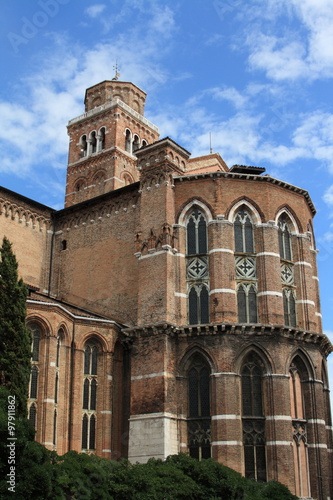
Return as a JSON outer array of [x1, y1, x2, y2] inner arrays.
[[0, 0, 333, 394]]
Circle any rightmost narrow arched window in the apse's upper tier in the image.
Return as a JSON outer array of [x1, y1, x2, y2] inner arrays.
[[278, 214, 297, 327]]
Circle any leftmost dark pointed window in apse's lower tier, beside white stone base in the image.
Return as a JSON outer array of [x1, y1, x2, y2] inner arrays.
[[187, 355, 211, 460]]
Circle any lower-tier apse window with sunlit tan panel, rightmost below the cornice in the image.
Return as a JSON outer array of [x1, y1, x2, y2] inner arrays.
[[289, 356, 311, 498]]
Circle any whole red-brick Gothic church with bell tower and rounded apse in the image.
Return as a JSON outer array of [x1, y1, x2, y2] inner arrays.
[[0, 80, 333, 500]]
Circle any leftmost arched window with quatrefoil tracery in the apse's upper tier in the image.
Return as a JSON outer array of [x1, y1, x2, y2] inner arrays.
[[186, 208, 209, 325]]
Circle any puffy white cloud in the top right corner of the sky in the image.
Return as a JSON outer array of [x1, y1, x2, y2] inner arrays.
[[242, 0, 333, 81]]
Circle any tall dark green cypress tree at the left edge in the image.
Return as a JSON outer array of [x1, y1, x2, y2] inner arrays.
[[0, 237, 31, 417]]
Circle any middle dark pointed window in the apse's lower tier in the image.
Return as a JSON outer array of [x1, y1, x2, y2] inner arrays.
[[241, 353, 266, 481]]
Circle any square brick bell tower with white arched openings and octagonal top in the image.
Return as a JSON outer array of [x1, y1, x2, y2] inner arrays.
[[65, 79, 159, 207]]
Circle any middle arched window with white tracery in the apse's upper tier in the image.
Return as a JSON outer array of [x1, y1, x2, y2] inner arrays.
[[234, 205, 258, 323]]
